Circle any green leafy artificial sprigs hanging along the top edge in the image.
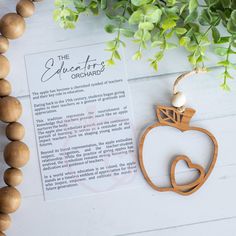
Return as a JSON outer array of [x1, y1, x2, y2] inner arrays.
[[54, 0, 236, 90]]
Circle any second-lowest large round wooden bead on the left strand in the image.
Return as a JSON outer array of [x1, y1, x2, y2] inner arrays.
[[4, 141, 30, 168]]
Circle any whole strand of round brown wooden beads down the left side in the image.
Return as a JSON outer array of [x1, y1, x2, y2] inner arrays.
[[0, 0, 41, 236]]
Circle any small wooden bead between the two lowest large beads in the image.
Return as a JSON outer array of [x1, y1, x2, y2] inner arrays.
[[3, 168, 23, 187]]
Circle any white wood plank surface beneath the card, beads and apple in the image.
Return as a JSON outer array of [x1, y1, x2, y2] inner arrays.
[[0, 0, 236, 236]]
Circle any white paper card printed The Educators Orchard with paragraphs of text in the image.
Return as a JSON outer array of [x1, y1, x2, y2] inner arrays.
[[25, 44, 137, 200]]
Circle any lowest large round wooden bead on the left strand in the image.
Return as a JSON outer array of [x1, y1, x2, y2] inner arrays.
[[0, 186, 21, 214]]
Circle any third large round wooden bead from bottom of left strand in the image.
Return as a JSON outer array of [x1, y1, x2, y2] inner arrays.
[[0, 96, 22, 123]]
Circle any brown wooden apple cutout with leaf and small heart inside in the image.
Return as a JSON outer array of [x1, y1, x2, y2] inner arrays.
[[139, 106, 218, 195]]
